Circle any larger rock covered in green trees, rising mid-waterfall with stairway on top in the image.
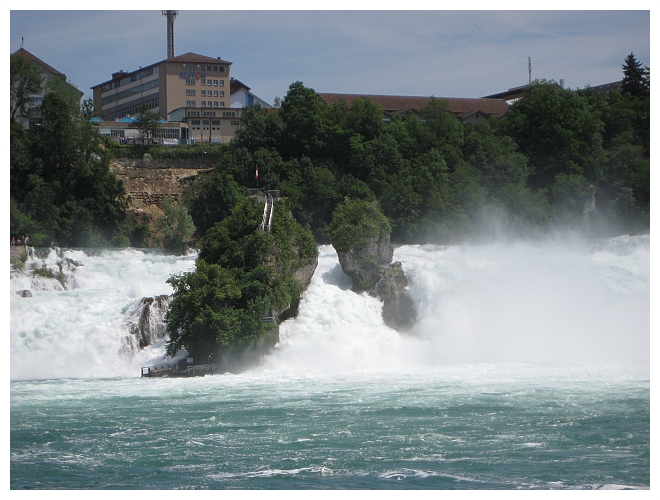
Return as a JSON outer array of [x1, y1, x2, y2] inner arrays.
[[167, 198, 317, 370]]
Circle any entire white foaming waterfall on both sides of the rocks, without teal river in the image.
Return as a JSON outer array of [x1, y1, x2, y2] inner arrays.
[[10, 236, 650, 380]]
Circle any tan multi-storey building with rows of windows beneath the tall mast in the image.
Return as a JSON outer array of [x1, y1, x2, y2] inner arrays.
[[92, 52, 266, 142]]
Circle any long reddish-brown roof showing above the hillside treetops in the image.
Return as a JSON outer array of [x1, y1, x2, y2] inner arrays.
[[318, 94, 509, 116]]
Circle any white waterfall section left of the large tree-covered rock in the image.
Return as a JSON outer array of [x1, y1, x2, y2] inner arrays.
[[10, 249, 195, 380]]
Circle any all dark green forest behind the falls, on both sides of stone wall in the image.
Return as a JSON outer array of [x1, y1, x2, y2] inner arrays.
[[10, 54, 650, 250]]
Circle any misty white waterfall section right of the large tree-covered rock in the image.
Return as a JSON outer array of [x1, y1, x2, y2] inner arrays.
[[267, 236, 650, 372]]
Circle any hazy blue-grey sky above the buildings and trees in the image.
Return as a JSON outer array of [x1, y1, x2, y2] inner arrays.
[[10, 5, 651, 103]]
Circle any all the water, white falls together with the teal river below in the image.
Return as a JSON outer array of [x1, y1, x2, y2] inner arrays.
[[10, 236, 650, 490]]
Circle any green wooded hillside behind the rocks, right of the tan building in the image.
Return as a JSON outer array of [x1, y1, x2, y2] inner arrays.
[[191, 56, 650, 243]]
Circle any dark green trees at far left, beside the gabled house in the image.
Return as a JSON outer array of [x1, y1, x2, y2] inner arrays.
[[10, 78, 126, 246]]
